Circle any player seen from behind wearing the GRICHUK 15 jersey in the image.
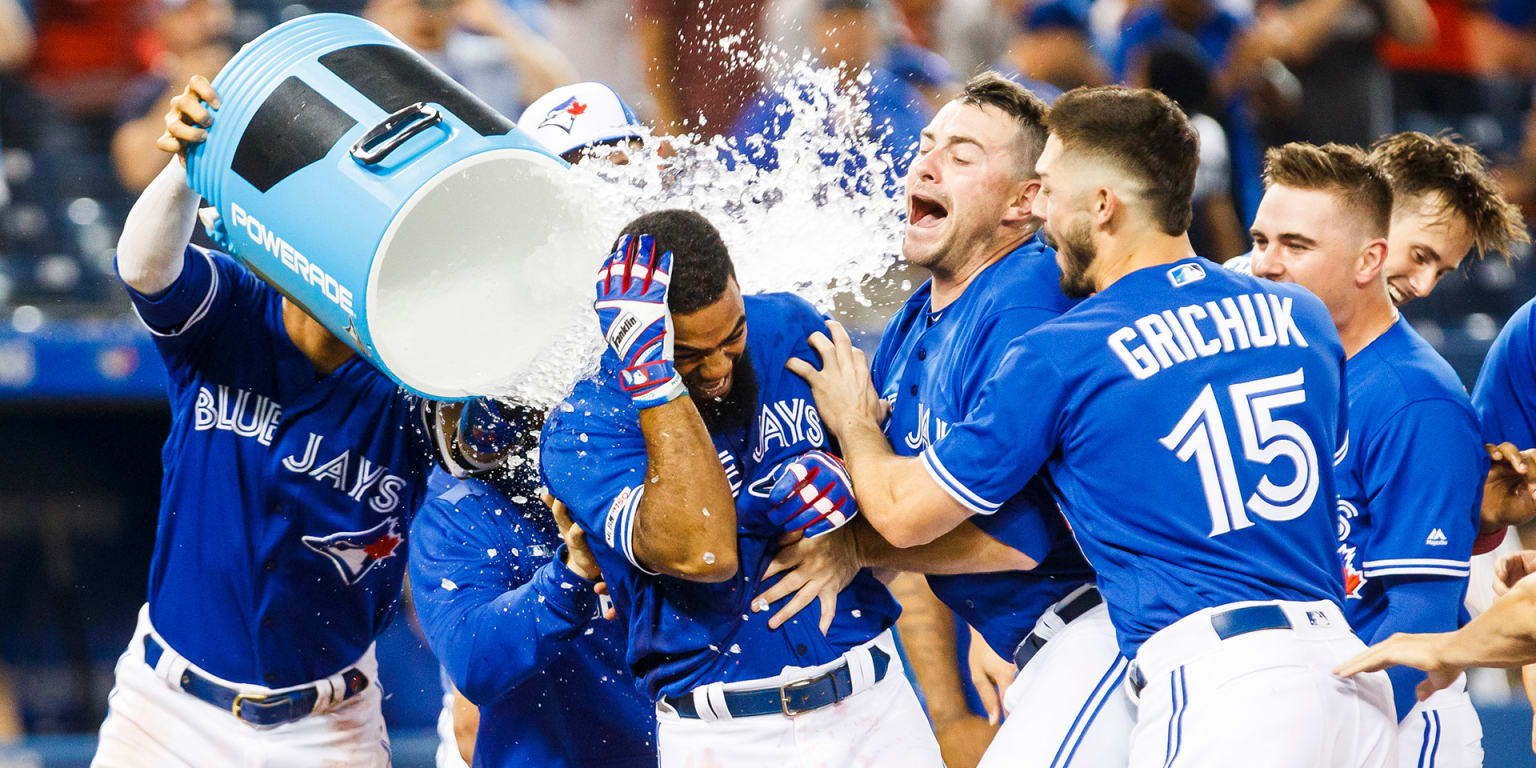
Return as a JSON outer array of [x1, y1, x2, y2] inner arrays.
[[791, 88, 1396, 768]]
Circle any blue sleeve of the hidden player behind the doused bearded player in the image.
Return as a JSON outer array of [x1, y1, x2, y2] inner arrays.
[[410, 496, 598, 705]]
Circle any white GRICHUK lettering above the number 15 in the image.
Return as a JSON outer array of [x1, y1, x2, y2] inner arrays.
[[1109, 293, 1307, 379]]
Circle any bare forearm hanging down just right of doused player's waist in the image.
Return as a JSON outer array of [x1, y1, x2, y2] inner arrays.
[[891, 573, 971, 725]]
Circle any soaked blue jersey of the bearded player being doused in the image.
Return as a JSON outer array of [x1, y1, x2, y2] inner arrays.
[[539, 293, 899, 697]]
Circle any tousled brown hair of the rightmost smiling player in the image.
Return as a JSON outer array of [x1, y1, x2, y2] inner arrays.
[[1370, 131, 1531, 260]]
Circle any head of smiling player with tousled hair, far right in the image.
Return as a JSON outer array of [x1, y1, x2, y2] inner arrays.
[[1370, 131, 1533, 305]]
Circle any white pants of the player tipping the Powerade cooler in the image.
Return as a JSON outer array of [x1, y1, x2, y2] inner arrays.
[[91, 605, 390, 768]]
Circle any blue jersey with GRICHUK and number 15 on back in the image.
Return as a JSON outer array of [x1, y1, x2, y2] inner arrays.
[[922, 258, 1344, 656]]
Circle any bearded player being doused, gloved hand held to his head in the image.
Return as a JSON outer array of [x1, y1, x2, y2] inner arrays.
[[539, 210, 940, 766]]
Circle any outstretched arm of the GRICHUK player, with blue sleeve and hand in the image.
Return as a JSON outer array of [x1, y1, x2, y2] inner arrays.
[[788, 321, 1058, 548]]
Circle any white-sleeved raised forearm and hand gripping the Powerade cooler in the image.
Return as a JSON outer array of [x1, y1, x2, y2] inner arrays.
[[117, 77, 218, 295]]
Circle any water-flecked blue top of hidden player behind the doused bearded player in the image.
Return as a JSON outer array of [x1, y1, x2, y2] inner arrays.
[[410, 473, 656, 768]]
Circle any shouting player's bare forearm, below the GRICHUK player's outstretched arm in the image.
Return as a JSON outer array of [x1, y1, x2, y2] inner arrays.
[[849, 518, 1038, 574]]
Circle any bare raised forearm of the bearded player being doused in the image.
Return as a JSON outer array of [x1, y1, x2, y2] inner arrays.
[[633, 396, 736, 581]]
